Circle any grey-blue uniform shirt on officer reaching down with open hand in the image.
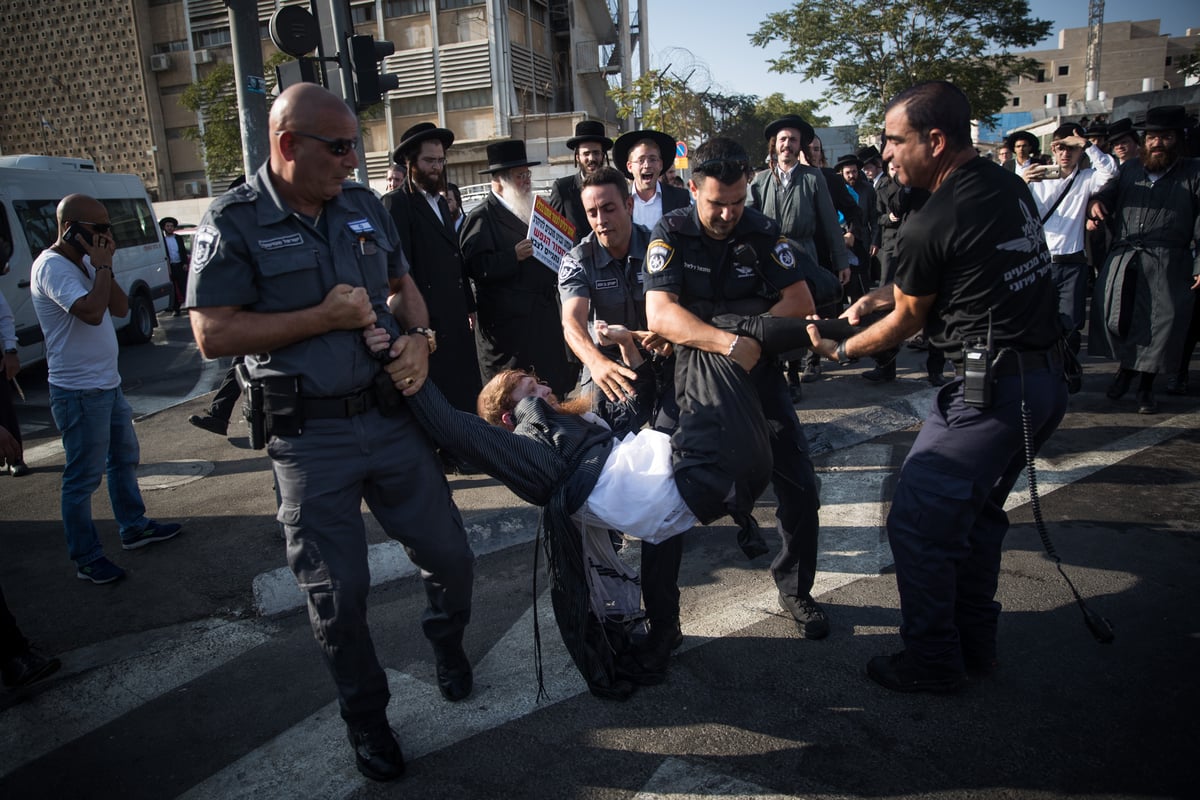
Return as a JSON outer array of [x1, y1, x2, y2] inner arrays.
[[558, 223, 650, 330]]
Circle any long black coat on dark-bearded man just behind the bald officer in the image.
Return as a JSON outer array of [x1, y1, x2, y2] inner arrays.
[[383, 184, 482, 413]]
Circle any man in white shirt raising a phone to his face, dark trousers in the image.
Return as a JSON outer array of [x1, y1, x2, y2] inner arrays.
[[1020, 122, 1117, 353]]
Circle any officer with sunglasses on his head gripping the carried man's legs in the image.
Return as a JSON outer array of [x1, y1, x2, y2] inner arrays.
[[644, 137, 829, 639]]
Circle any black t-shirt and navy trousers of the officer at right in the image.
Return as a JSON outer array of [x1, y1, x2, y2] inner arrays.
[[887, 158, 1067, 685]]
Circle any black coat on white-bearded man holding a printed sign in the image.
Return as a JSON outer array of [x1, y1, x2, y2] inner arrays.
[[461, 194, 578, 397]]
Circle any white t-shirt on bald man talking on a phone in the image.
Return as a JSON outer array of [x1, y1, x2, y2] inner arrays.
[[30, 249, 121, 391]]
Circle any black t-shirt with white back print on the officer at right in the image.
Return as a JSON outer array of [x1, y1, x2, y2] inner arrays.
[[895, 158, 1060, 350]]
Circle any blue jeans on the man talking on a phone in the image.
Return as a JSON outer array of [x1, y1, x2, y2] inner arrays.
[[50, 384, 148, 566]]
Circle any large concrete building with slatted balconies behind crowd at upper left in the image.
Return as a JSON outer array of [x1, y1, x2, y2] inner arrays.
[[0, 0, 643, 200]]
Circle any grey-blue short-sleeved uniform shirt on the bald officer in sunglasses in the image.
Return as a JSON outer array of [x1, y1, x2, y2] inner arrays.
[[187, 163, 408, 397]]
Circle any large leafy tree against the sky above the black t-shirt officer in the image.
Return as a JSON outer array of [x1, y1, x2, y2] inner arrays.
[[750, 0, 1054, 127]]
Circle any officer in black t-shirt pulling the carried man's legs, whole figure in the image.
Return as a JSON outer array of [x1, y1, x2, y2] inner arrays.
[[809, 80, 1067, 692]]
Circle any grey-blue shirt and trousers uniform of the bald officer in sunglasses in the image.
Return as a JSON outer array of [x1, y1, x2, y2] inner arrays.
[[187, 164, 474, 724]]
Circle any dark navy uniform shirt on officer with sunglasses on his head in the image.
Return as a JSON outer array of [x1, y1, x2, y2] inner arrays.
[[643, 206, 803, 321]]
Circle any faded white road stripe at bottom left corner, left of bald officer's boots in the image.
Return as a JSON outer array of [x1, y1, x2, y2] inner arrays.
[[0, 619, 275, 775]]
